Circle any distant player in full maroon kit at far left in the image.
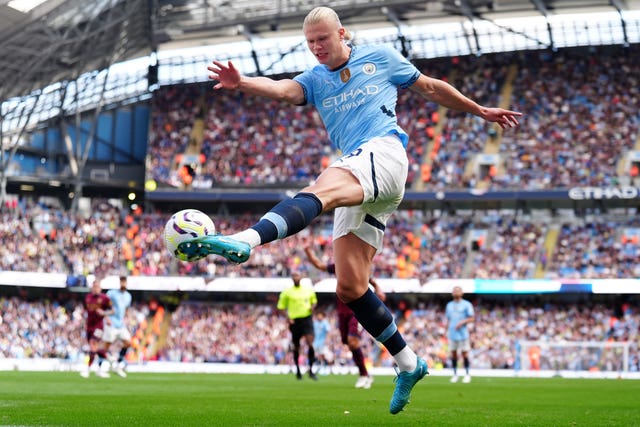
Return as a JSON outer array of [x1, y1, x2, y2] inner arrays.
[[80, 279, 113, 378]]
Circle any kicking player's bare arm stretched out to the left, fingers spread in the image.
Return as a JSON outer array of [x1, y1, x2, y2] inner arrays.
[[207, 61, 305, 105]]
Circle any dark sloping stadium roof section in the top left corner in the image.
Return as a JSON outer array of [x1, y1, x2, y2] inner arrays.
[[0, 0, 151, 100]]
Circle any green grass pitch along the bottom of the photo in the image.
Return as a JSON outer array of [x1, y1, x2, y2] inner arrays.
[[0, 372, 640, 426]]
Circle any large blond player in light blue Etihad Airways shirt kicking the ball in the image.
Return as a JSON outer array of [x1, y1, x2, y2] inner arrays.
[[179, 7, 521, 414]]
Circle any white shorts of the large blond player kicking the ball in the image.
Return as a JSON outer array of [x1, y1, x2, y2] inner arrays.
[[329, 135, 409, 252]]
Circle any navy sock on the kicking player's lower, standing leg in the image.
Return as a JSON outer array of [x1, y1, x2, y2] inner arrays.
[[347, 289, 407, 356]]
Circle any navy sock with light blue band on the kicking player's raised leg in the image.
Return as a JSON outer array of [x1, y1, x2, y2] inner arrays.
[[251, 193, 322, 244]]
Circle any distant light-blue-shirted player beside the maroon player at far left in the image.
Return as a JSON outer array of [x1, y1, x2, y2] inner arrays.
[[103, 276, 131, 378]]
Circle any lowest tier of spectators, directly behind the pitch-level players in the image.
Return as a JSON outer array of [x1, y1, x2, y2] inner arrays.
[[0, 297, 640, 371]]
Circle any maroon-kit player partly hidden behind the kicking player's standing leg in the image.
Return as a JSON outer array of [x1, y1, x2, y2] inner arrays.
[[304, 246, 385, 388]]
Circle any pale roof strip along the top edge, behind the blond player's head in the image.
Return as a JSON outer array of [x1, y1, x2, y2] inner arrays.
[[156, 0, 633, 45]]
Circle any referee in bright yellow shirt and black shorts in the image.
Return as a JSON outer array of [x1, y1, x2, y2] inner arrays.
[[277, 272, 318, 380]]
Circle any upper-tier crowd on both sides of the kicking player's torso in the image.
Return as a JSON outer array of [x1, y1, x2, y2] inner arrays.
[[147, 46, 640, 190]]
